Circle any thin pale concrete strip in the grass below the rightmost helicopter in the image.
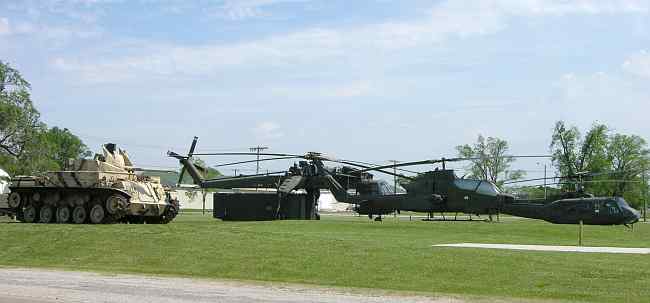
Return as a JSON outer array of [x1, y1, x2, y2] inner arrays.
[[432, 243, 650, 254]]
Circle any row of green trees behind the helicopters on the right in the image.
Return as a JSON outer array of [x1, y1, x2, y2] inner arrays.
[[456, 121, 650, 206]]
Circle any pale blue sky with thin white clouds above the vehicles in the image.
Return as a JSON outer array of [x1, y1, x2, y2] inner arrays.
[[0, 0, 650, 177]]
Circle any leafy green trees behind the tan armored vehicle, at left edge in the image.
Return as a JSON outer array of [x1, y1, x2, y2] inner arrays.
[[0, 60, 92, 176]]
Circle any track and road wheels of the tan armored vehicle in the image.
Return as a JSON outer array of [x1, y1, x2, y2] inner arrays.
[[9, 187, 178, 224]]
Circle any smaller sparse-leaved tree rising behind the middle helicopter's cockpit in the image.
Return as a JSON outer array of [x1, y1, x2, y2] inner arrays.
[[456, 135, 524, 185]]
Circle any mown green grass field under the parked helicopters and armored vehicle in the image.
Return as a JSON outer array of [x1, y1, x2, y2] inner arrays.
[[0, 212, 650, 302]]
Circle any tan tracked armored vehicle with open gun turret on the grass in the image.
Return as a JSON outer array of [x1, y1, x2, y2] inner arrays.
[[7, 143, 178, 224]]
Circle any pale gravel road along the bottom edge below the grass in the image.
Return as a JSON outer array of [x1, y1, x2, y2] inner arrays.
[[0, 268, 465, 303]]
